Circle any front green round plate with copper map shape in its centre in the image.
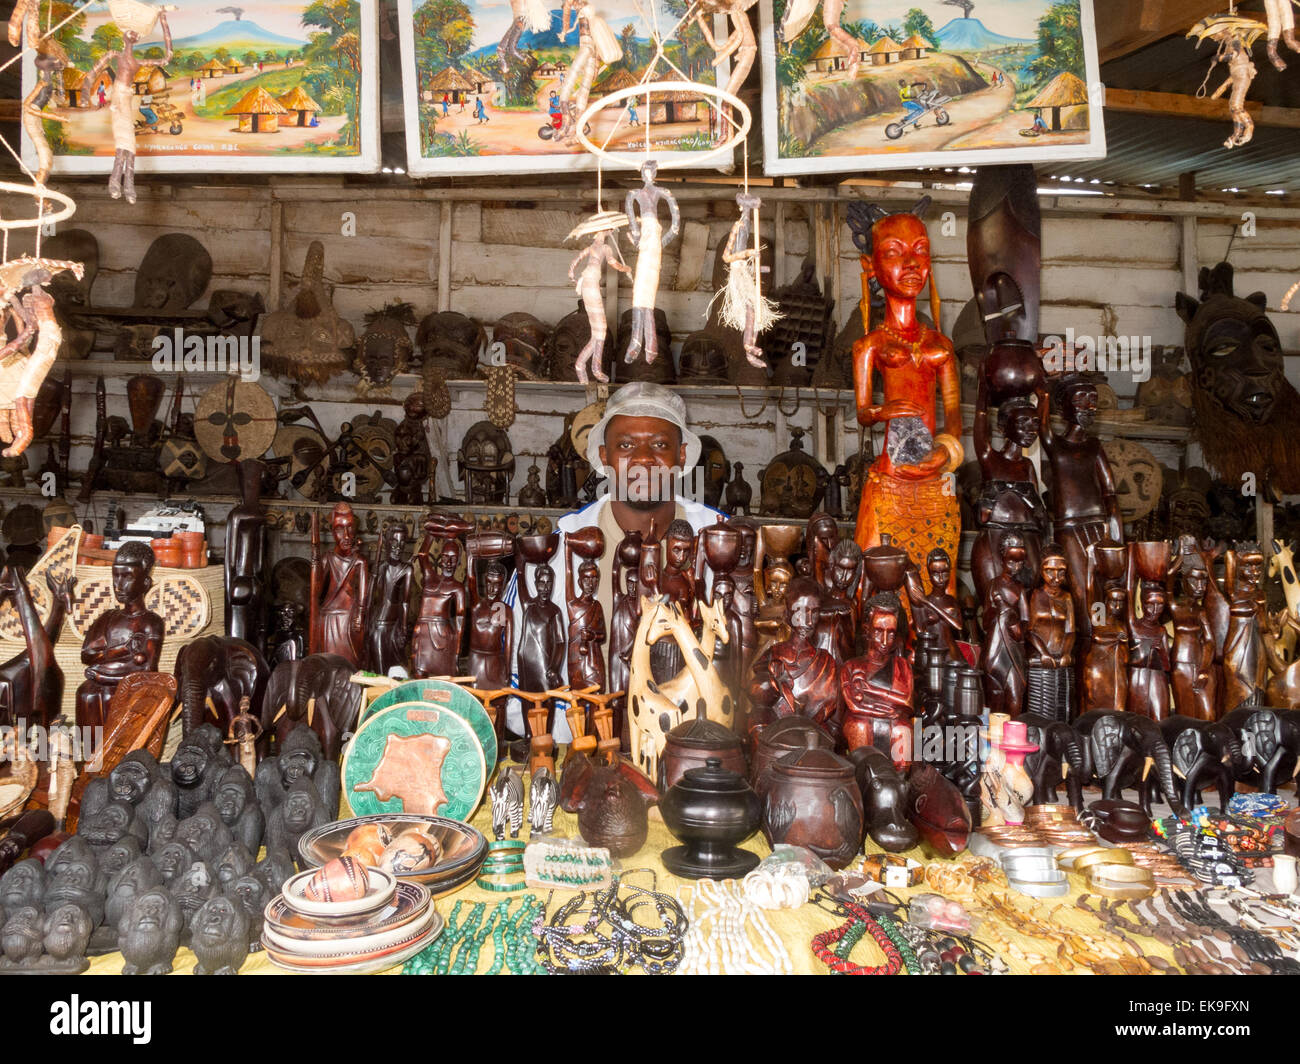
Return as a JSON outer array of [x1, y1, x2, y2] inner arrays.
[[343, 702, 488, 821]]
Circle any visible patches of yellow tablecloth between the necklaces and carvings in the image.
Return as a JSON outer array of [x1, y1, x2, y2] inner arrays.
[[78, 801, 1173, 976]]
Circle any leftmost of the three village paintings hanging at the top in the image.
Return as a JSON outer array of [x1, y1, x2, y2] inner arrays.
[[23, 0, 378, 172]]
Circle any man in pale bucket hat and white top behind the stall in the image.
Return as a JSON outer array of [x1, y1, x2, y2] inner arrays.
[[506, 381, 727, 741]]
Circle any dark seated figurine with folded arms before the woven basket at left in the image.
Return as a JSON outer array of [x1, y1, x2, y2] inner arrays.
[[77, 540, 163, 728]]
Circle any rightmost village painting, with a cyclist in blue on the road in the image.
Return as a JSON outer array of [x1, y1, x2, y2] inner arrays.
[[759, 0, 1106, 174]]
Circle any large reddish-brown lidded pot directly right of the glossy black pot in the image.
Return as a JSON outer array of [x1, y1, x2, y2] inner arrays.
[[757, 747, 865, 869]]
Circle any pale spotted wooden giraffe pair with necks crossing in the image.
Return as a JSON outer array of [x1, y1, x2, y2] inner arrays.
[[628, 596, 733, 779]]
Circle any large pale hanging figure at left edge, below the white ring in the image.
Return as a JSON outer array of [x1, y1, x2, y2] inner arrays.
[[0, 255, 83, 458]]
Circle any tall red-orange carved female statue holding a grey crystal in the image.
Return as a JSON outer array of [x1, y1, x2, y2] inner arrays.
[[849, 200, 962, 593]]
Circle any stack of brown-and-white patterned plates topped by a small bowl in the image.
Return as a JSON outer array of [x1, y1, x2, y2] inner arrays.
[[261, 869, 443, 976]]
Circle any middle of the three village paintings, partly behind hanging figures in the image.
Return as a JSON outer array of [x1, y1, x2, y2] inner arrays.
[[398, 0, 728, 176]]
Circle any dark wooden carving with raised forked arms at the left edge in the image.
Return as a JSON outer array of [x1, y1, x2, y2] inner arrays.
[[0, 566, 77, 726]]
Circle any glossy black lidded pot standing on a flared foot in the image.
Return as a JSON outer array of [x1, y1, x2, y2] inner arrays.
[[659, 757, 762, 879]]
